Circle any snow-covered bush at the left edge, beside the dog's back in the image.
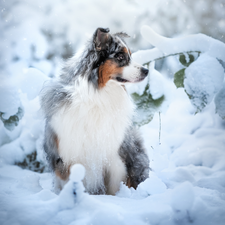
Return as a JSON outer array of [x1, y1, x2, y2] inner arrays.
[[0, 68, 48, 172]]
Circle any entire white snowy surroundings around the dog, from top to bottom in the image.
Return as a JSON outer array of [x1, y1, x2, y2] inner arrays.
[[0, 0, 225, 225]]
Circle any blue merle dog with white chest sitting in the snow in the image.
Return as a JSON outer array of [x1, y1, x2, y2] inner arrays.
[[40, 28, 149, 195]]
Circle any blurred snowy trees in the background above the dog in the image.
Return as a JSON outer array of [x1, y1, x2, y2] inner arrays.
[[0, 0, 225, 77]]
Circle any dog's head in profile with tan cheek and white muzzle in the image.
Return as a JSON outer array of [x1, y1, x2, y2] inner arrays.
[[92, 28, 148, 88]]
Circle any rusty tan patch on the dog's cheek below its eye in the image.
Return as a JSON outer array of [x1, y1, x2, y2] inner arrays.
[[98, 59, 123, 88]]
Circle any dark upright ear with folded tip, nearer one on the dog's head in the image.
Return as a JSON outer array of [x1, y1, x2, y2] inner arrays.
[[94, 28, 111, 51]]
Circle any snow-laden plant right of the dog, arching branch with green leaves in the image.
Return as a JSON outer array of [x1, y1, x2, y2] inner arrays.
[[133, 26, 225, 125]]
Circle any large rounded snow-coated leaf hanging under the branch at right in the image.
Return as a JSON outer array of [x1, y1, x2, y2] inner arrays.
[[184, 54, 224, 110]]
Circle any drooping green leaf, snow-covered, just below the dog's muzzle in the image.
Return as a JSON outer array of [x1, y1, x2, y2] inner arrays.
[[131, 84, 165, 126]]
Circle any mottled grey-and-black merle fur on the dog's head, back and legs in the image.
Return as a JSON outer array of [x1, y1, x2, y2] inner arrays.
[[41, 28, 149, 194]]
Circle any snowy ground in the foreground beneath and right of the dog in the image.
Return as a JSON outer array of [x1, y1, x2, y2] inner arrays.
[[0, 76, 225, 225]]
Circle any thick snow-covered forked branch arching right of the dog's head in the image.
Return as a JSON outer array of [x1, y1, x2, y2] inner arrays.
[[132, 26, 225, 64]]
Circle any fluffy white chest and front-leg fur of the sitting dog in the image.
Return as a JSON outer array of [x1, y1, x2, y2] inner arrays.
[[51, 80, 134, 192]]
